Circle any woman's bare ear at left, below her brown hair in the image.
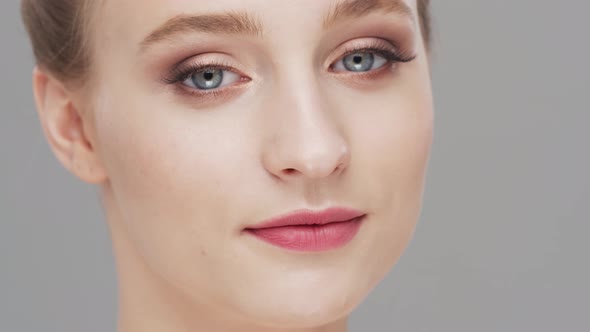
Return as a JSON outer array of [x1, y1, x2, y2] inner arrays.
[[33, 67, 107, 183]]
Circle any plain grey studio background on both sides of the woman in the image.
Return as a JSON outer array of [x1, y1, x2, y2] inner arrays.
[[0, 0, 590, 332]]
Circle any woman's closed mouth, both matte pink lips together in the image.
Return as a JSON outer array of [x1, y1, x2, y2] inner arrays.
[[244, 207, 366, 252]]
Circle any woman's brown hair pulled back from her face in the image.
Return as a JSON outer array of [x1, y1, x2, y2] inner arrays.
[[21, 0, 431, 82]]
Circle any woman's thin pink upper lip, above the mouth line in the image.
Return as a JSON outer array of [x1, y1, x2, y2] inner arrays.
[[247, 207, 364, 229]]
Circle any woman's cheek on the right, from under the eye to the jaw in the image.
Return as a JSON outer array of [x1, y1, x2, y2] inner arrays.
[[351, 74, 434, 285]]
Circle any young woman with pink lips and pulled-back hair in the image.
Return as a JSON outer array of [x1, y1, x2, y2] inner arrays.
[[22, 0, 434, 332]]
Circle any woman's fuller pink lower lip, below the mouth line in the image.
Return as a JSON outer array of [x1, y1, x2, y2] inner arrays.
[[246, 216, 364, 252]]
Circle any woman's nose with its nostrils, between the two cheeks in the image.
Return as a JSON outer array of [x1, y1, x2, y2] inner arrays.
[[262, 81, 351, 181]]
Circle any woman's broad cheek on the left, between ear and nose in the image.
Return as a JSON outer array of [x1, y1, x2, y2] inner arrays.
[[90, 89, 252, 264]]
